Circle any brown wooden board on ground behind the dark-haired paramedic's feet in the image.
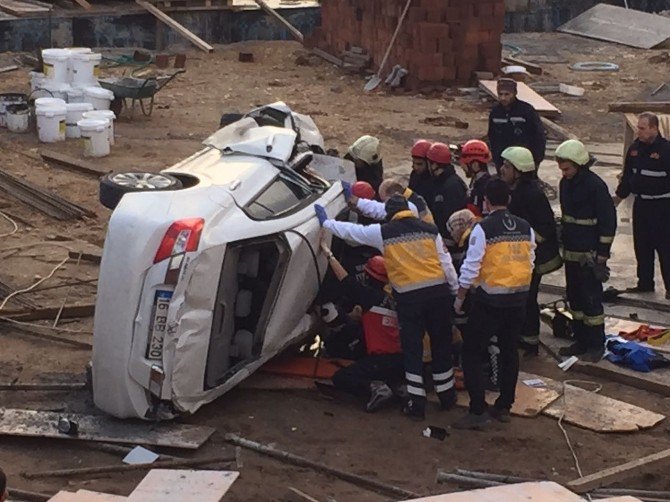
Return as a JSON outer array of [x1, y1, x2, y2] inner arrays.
[[456, 372, 563, 417]]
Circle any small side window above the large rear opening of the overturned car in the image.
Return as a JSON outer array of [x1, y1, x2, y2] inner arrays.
[[245, 175, 314, 220]]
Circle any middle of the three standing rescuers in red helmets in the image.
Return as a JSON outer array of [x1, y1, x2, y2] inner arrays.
[[426, 143, 468, 238]]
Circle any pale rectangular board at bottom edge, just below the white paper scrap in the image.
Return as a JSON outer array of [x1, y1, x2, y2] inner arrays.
[[128, 469, 240, 502]]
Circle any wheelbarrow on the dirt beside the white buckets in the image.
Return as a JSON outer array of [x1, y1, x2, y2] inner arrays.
[[99, 69, 186, 118]]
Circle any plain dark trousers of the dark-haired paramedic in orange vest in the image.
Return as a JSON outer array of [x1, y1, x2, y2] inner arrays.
[[463, 298, 526, 415]]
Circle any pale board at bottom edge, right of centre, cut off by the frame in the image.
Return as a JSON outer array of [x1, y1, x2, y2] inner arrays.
[[405, 481, 583, 502]]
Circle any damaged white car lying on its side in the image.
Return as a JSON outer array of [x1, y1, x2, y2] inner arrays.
[[92, 103, 354, 420]]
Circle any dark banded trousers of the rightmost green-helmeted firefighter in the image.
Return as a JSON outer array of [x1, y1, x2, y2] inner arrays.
[[565, 261, 605, 348]]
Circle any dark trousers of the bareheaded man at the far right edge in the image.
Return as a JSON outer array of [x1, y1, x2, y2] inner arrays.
[[633, 197, 670, 292]]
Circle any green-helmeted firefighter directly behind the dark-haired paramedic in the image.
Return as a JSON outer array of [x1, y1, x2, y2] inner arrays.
[[500, 146, 563, 356]]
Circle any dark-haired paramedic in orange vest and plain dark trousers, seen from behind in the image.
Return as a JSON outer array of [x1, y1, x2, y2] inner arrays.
[[453, 179, 535, 430]]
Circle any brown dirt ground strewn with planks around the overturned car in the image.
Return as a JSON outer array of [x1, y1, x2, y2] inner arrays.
[[0, 34, 670, 501]]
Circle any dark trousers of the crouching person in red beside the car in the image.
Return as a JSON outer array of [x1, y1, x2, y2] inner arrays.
[[333, 354, 403, 397]]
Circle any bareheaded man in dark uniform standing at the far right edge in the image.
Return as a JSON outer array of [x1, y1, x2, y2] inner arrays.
[[614, 112, 670, 300]]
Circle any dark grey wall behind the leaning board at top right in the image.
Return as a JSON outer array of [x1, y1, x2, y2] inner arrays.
[[505, 0, 670, 33]]
